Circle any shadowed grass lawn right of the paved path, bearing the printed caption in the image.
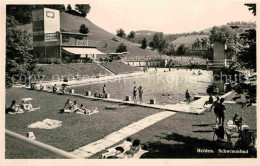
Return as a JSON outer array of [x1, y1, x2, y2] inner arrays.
[[92, 104, 256, 158]]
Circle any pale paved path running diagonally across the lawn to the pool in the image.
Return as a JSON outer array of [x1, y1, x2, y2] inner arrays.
[[71, 111, 176, 158]]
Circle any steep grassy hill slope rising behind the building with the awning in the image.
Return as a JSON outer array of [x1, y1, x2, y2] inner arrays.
[[18, 12, 168, 58]]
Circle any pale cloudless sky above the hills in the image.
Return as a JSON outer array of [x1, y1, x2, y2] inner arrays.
[[71, 0, 256, 34]]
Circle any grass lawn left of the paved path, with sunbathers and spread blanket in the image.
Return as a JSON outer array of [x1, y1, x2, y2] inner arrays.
[[5, 88, 159, 158]]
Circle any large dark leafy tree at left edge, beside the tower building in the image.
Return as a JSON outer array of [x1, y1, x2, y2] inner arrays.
[[5, 16, 39, 88]]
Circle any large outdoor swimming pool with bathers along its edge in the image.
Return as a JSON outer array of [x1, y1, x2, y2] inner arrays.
[[68, 69, 212, 105]]
